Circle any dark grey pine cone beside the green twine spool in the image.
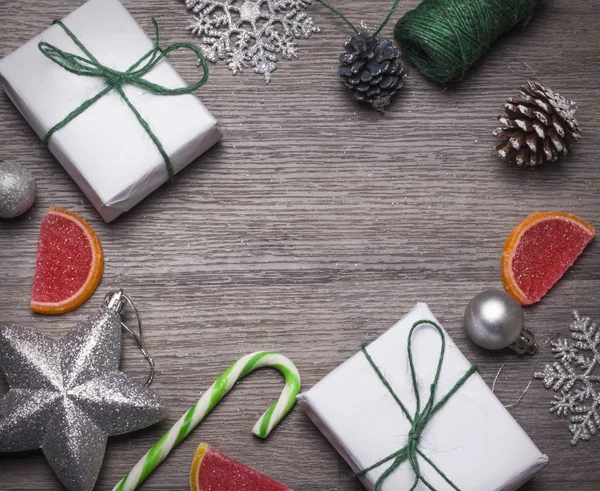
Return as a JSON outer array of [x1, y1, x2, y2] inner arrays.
[[338, 34, 408, 111]]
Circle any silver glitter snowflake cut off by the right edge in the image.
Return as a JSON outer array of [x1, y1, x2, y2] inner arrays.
[[534, 311, 600, 445]]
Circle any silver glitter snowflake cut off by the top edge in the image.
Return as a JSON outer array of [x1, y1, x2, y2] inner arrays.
[[185, 0, 319, 83]]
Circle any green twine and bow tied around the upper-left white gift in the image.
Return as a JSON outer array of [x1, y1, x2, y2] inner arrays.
[[38, 18, 208, 179]]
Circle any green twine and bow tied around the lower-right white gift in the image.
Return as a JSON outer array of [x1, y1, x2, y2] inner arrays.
[[356, 320, 477, 491]]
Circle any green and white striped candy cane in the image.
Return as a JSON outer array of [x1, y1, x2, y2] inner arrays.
[[113, 351, 300, 491]]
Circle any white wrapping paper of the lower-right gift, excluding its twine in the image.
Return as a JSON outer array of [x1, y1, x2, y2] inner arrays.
[[298, 303, 548, 491]]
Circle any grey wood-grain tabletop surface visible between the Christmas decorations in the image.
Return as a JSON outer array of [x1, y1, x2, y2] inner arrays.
[[0, 0, 600, 491]]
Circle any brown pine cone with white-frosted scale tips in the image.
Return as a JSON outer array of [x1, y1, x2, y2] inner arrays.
[[494, 81, 581, 167]]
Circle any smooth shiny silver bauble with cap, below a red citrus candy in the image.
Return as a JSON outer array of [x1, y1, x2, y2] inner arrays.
[[465, 290, 536, 354]]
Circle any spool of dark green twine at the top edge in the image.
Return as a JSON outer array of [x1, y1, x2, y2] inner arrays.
[[394, 0, 543, 83]]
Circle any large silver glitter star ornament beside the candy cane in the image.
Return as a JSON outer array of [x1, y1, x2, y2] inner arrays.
[[0, 292, 166, 491]]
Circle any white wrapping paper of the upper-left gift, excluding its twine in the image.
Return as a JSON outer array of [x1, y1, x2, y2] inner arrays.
[[0, 0, 221, 221]]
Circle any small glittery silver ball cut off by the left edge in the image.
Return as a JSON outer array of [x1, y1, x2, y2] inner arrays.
[[0, 162, 36, 218]]
